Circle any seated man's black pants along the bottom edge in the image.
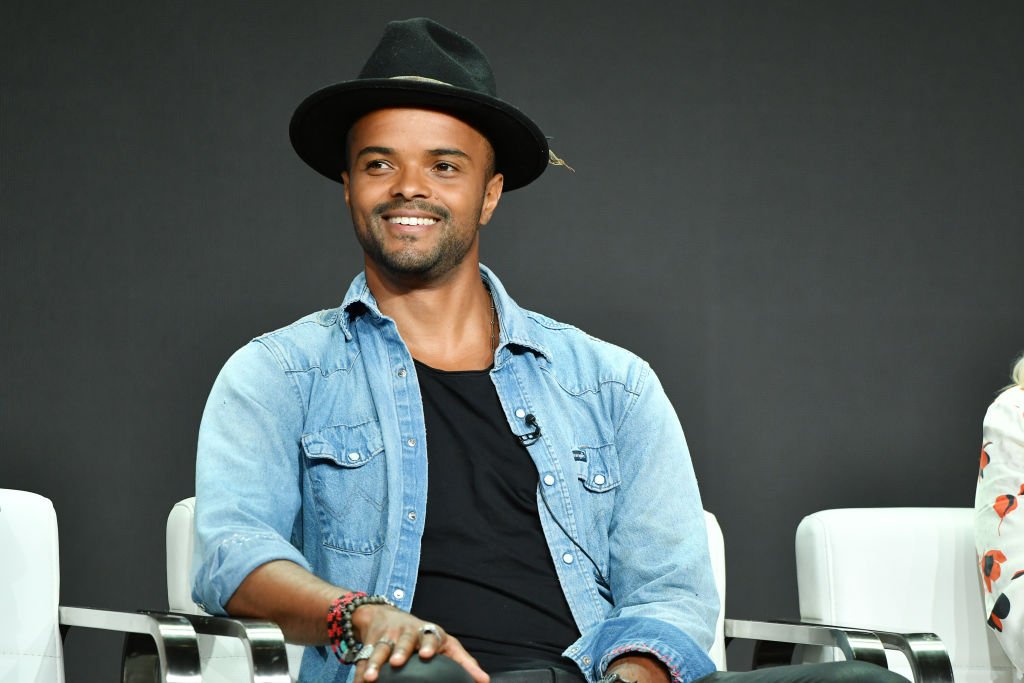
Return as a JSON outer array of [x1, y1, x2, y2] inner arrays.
[[378, 655, 907, 683]]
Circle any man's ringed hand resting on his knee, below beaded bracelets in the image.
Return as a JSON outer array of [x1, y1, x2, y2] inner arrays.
[[352, 605, 490, 683]]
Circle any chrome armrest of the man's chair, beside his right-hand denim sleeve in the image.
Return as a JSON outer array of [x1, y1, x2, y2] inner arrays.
[[725, 618, 889, 669]]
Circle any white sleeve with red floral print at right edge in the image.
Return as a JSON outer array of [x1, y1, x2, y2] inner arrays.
[[974, 386, 1024, 671]]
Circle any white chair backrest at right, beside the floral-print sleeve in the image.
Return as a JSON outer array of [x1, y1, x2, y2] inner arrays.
[[797, 508, 1016, 683]]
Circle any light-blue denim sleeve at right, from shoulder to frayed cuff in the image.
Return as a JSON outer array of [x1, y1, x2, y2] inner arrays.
[[573, 364, 720, 683]]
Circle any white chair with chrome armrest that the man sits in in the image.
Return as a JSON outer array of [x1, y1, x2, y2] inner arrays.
[[167, 498, 913, 681]]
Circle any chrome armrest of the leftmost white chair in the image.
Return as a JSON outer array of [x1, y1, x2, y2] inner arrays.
[[57, 606, 202, 683]]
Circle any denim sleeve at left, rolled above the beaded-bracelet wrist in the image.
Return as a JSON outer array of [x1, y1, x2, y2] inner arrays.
[[193, 340, 309, 613]]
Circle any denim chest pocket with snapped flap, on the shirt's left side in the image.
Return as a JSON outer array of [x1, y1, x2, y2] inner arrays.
[[302, 421, 387, 555]]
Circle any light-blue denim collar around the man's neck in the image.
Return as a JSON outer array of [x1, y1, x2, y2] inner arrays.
[[338, 263, 551, 360]]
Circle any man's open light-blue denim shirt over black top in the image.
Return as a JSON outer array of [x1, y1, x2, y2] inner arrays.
[[193, 266, 719, 683]]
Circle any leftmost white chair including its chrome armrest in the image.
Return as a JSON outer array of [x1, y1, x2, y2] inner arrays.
[[0, 488, 200, 683]]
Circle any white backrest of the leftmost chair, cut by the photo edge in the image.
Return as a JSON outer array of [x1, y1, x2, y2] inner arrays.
[[0, 488, 65, 683]]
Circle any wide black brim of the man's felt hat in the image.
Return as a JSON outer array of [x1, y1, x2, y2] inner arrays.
[[289, 79, 548, 190]]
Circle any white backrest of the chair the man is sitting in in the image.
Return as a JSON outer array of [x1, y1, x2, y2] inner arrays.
[[167, 498, 725, 678]]
